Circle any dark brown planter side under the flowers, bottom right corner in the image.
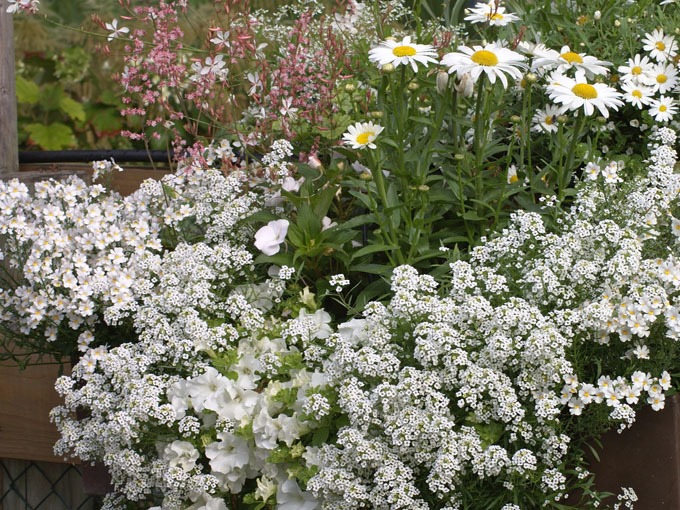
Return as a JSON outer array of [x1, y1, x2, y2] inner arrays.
[[591, 395, 680, 510]]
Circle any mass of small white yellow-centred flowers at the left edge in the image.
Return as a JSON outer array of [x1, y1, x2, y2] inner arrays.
[[0, 173, 162, 352]]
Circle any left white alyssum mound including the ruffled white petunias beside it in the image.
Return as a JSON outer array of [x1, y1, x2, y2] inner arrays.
[[52, 145, 330, 510]]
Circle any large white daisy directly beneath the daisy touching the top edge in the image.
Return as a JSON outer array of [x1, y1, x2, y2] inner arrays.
[[441, 43, 526, 88]]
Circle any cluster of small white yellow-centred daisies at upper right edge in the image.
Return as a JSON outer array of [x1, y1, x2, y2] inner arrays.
[[618, 28, 680, 122]]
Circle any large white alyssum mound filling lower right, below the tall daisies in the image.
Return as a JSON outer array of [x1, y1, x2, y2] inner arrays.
[[307, 129, 680, 510]]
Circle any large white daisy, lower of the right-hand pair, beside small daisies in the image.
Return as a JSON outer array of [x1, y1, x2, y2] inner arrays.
[[547, 76, 623, 118]]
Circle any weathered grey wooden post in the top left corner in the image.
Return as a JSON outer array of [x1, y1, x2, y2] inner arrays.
[[0, 0, 19, 178]]
